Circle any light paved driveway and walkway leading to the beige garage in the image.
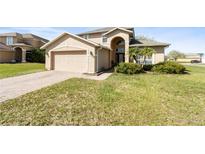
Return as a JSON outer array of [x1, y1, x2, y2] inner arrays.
[[0, 71, 112, 102]]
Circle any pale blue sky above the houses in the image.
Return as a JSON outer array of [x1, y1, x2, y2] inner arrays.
[[0, 27, 205, 53]]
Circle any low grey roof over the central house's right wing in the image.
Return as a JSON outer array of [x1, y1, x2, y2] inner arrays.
[[130, 38, 170, 47]]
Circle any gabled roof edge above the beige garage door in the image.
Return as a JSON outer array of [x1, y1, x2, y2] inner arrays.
[[41, 33, 108, 49]]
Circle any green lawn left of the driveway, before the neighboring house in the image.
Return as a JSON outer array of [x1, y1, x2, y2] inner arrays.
[[0, 63, 45, 79]]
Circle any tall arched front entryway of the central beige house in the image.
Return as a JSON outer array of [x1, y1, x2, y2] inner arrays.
[[111, 37, 125, 64]]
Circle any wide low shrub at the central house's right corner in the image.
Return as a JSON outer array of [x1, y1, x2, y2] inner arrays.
[[152, 61, 186, 74]]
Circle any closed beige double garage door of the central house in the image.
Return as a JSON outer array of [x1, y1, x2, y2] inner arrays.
[[54, 51, 88, 73]]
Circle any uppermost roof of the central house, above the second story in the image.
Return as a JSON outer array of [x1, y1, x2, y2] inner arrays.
[[78, 27, 134, 35]]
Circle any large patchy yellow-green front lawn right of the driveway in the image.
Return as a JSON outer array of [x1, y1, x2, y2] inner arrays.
[[0, 66, 205, 125]]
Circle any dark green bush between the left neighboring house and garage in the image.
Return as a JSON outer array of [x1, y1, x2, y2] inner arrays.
[[26, 49, 45, 63]]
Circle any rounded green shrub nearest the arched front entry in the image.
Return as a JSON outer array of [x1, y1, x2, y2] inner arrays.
[[115, 63, 143, 74]]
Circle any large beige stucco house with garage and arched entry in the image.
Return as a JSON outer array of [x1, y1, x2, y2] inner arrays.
[[41, 27, 169, 73]]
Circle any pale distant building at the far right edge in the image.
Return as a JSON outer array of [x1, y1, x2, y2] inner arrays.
[[177, 53, 203, 63]]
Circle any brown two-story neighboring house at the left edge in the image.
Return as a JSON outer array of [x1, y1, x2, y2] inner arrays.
[[0, 33, 48, 63]]
